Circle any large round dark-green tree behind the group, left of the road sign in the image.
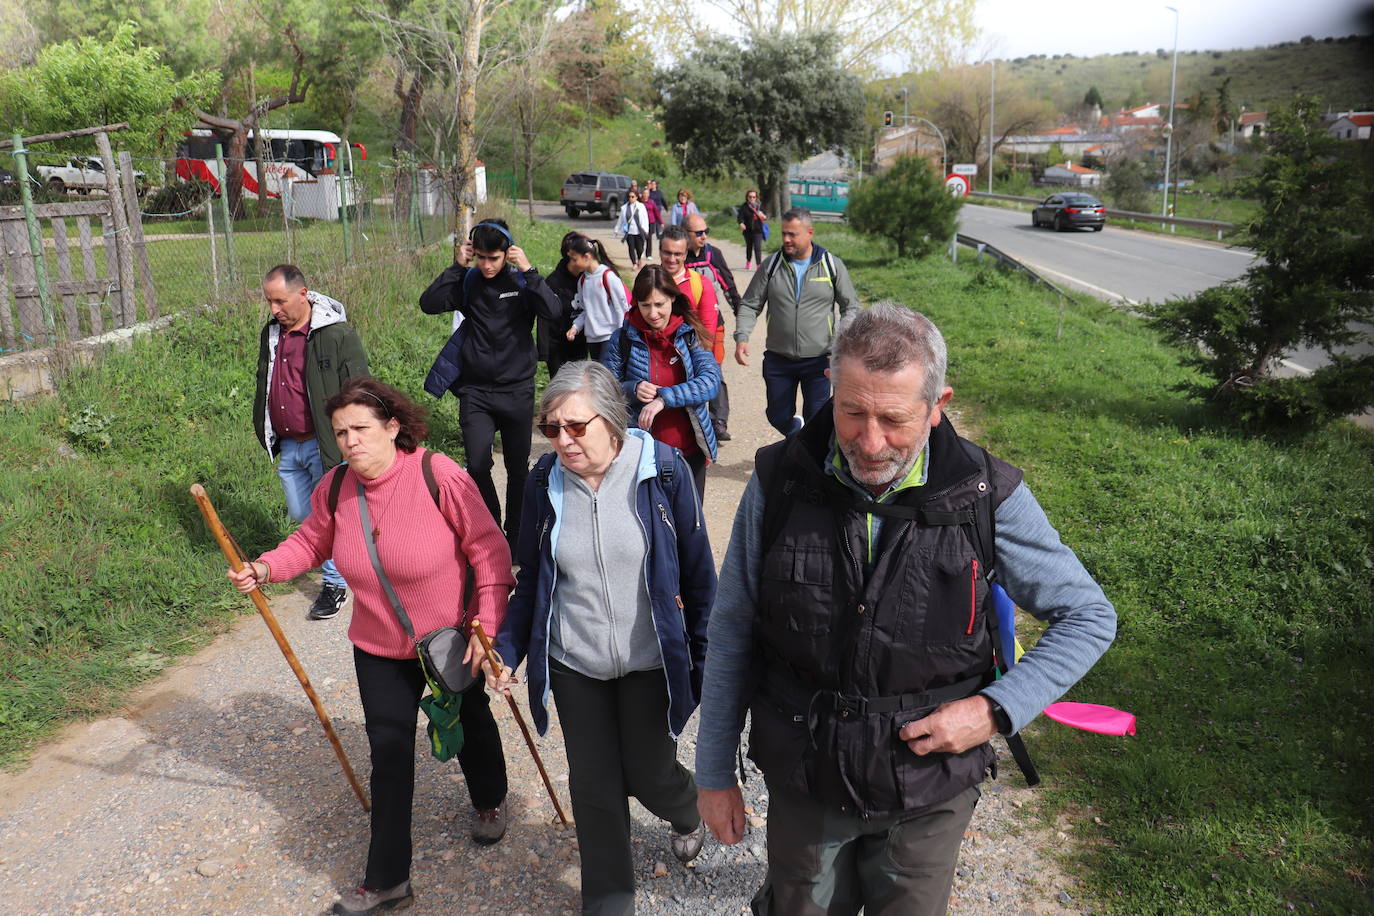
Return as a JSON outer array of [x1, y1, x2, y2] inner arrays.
[[655, 32, 864, 214]]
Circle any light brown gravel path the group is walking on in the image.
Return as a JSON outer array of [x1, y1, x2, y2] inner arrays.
[[0, 220, 1083, 916]]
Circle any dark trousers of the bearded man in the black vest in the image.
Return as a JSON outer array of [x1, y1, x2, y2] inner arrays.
[[753, 786, 981, 916]]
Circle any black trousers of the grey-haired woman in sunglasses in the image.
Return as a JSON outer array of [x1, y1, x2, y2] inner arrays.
[[548, 659, 701, 916]]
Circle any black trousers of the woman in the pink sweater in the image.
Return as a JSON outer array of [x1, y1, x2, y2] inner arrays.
[[353, 645, 506, 889]]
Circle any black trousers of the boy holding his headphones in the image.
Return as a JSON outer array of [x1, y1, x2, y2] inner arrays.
[[458, 380, 534, 548]]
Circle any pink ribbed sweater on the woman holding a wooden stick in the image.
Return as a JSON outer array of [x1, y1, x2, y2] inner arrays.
[[258, 449, 515, 658]]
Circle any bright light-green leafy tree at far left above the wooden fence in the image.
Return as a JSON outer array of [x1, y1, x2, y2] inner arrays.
[[0, 22, 218, 155]]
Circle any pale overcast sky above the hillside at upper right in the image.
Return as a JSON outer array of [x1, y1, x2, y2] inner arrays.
[[976, 0, 1374, 59]]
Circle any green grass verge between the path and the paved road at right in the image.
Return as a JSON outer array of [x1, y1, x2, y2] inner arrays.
[[818, 219, 1374, 913]]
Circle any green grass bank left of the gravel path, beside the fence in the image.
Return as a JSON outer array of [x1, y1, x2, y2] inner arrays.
[[0, 204, 561, 766]]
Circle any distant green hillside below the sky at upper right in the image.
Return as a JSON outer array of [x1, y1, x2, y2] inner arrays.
[[998, 36, 1374, 120]]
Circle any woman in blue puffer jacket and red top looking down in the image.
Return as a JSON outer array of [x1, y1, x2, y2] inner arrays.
[[602, 264, 720, 497]]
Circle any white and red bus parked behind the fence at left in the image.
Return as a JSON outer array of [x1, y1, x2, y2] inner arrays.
[[176, 128, 367, 215]]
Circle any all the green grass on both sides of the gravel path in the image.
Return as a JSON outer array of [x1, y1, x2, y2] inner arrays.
[[0, 194, 1374, 913]]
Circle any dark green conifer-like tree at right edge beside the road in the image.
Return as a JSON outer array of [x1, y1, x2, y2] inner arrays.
[[1147, 96, 1374, 424]]
